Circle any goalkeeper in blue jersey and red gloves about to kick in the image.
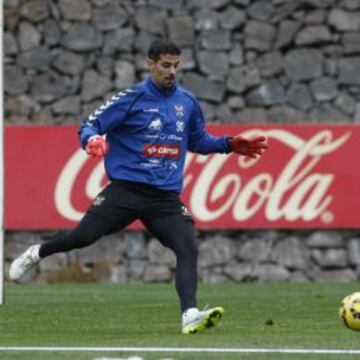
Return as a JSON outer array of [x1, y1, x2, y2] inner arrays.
[[9, 40, 267, 334]]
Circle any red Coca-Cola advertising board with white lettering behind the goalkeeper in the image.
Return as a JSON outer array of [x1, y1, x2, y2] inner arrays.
[[5, 124, 360, 230]]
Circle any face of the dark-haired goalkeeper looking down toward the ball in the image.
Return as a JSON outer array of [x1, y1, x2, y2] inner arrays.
[[148, 54, 180, 89]]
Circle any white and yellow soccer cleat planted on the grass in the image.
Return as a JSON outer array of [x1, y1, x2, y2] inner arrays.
[[182, 306, 225, 334]]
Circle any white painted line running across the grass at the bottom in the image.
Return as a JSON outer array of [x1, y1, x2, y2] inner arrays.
[[0, 346, 360, 355]]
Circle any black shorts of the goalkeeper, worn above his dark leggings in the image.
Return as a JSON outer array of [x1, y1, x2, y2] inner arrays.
[[88, 180, 193, 223]]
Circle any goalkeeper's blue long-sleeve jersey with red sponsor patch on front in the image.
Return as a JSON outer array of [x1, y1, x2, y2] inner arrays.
[[79, 76, 230, 193]]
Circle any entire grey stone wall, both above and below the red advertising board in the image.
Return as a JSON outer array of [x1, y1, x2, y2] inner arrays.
[[3, 0, 360, 282]]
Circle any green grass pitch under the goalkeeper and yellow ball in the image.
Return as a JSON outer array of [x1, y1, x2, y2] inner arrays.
[[0, 283, 360, 360]]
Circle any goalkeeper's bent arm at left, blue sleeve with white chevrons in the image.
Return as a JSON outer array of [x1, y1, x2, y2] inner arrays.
[[78, 89, 140, 149]]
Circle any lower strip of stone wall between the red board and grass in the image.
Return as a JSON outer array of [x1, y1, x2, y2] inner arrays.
[[5, 231, 360, 283]]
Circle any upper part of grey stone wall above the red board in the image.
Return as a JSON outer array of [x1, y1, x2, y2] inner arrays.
[[4, 0, 360, 124]]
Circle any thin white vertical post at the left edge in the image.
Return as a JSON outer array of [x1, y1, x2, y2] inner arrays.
[[0, 0, 4, 305]]
